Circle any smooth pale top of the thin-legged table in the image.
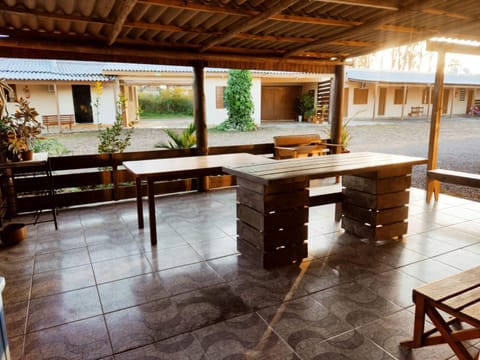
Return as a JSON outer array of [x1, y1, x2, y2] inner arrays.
[[123, 153, 275, 179]]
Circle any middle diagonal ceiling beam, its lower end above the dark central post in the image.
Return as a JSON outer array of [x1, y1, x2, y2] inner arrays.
[[201, 0, 299, 52]]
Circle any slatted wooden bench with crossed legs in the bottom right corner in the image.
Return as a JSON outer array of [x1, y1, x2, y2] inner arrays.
[[401, 266, 480, 360]]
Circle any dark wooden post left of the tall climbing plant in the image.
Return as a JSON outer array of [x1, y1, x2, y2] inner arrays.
[[193, 64, 209, 191]]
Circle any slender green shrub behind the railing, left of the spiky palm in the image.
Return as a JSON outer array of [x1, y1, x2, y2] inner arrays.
[[98, 98, 134, 154]]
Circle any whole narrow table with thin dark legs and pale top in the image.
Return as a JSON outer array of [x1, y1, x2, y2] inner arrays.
[[123, 153, 274, 245]]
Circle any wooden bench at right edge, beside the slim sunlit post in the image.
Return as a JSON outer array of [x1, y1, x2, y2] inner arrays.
[[427, 169, 480, 203]]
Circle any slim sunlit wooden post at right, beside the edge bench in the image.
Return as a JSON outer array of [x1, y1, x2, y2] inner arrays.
[[427, 51, 445, 202]]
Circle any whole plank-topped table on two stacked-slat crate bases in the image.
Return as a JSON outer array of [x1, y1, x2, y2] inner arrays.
[[223, 152, 427, 268]]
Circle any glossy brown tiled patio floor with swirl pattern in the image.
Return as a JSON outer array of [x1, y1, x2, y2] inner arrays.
[[0, 189, 480, 360]]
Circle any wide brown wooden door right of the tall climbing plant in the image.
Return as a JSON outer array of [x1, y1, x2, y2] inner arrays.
[[261, 86, 302, 120]]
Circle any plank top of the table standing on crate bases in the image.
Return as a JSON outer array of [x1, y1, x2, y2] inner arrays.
[[223, 152, 427, 185]]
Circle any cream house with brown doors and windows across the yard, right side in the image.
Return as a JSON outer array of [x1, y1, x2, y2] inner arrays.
[[344, 69, 480, 119]]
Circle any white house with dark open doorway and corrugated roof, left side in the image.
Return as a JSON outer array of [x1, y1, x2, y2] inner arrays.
[[0, 58, 329, 126]]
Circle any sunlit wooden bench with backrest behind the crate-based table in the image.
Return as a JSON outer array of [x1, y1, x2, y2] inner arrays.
[[273, 134, 329, 160]]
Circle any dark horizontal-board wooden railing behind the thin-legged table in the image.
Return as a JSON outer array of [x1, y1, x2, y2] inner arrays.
[[9, 143, 273, 213]]
